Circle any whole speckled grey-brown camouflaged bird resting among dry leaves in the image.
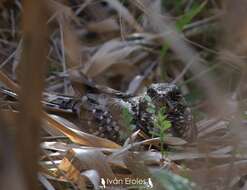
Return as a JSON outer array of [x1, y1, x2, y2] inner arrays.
[[1, 83, 197, 143]]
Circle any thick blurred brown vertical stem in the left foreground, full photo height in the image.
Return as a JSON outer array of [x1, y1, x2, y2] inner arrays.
[[16, 0, 48, 190]]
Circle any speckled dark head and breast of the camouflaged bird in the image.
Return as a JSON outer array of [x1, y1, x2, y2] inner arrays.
[[133, 83, 197, 141]]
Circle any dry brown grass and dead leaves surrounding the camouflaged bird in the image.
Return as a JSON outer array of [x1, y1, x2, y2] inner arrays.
[[0, 0, 247, 190]]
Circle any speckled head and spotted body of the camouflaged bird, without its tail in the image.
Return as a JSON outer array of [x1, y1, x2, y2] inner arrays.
[[79, 83, 197, 142]]
